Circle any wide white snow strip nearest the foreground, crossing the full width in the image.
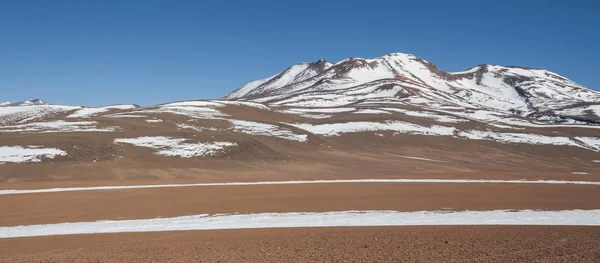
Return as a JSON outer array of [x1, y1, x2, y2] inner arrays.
[[0, 210, 600, 238]]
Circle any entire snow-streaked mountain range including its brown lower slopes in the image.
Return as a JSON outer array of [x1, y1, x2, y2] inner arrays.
[[0, 53, 600, 176]]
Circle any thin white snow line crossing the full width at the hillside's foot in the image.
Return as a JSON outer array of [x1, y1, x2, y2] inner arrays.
[[0, 179, 600, 195]]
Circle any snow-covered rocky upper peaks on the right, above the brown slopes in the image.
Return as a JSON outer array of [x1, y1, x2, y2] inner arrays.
[[224, 53, 600, 116]]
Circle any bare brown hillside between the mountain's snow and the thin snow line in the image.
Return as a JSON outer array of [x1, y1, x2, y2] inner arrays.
[[0, 120, 600, 187]]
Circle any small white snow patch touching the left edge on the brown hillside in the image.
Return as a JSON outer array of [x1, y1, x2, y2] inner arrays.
[[0, 146, 67, 163]]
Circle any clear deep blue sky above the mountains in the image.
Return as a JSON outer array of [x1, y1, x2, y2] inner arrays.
[[0, 0, 600, 106]]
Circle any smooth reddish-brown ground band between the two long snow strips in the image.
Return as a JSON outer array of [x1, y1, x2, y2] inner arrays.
[[0, 183, 600, 226]]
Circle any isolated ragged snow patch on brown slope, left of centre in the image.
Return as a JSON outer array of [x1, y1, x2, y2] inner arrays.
[[115, 136, 237, 158]]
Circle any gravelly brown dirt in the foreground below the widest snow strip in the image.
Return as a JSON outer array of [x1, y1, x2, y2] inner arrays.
[[0, 226, 600, 262]]
